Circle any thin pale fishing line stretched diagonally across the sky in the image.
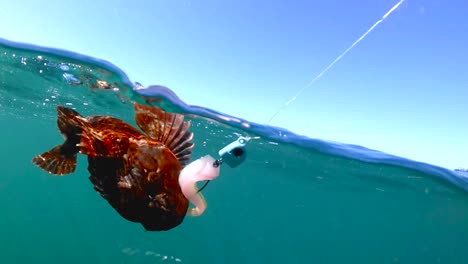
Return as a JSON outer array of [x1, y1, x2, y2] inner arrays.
[[265, 0, 405, 124]]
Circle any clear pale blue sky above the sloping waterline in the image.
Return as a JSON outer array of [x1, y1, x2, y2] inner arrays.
[[0, 0, 468, 168]]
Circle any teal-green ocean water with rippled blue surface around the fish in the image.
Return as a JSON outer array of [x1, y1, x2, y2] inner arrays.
[[0, 39, 468, 264]]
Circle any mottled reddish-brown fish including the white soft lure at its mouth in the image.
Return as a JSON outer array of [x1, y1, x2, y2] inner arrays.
[[32, 103, 219, 231]]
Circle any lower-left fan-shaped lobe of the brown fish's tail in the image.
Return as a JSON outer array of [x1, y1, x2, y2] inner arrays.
[[32, 145, 76, 175]]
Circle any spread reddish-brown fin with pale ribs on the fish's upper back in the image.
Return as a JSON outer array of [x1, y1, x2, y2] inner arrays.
[[134, 103, 194, 167]]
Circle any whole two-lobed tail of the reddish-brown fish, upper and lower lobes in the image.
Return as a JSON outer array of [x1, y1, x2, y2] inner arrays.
[[32, 106, 85, 175]]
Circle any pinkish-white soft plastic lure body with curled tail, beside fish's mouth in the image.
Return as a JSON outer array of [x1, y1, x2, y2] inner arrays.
[[179, 155, 219, 216]]
